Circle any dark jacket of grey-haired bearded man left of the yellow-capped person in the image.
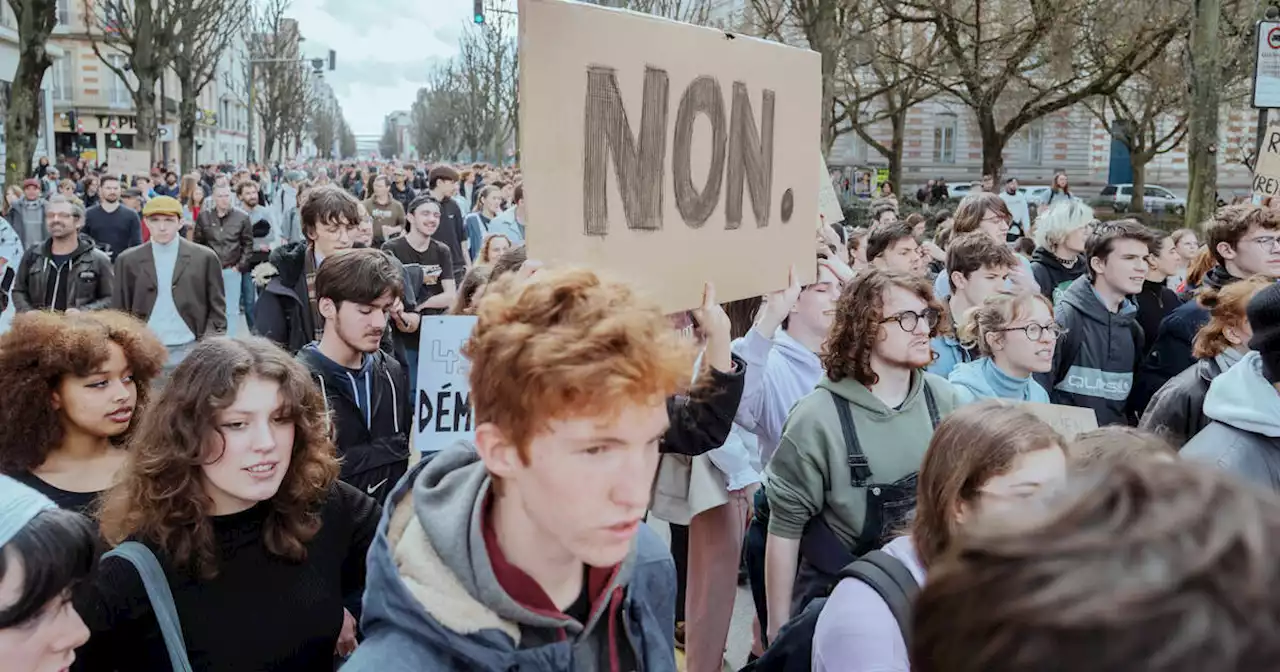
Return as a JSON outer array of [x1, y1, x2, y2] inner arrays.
[[13, 236, 115, 312]]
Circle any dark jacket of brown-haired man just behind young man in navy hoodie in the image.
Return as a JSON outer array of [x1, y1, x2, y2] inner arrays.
[[253, 241, 316, 353]]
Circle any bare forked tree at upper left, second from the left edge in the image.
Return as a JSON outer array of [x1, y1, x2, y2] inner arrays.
[[83, 0, 182, 152]]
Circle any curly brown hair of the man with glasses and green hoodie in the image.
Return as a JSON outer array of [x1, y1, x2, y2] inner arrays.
[[820, 270, 951, 387]]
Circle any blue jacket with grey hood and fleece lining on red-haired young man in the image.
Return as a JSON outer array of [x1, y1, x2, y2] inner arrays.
[[343, 444, 676, 672]]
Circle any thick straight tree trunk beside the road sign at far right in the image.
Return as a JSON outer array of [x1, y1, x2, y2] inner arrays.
[[1185, 0, 1222, 227]]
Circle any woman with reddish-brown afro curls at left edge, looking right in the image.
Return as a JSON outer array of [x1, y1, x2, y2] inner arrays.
[[0, 311, 169, 515]]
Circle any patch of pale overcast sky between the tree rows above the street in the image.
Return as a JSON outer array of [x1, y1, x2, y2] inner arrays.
[[289, 0, 472, 134]]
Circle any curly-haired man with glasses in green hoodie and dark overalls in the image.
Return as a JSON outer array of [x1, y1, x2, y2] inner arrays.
[[764, 270, 956, 639]]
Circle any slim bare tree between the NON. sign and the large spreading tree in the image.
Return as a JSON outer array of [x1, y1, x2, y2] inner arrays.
[[832, 0, 941, 193]]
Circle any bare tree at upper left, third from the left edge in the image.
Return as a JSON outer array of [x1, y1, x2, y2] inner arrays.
[[172, 0, 250, 173]]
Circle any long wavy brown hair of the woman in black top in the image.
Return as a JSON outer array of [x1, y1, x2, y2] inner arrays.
[[100, 337, 338, 579]]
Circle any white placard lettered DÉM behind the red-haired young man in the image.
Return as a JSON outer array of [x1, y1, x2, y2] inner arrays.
[[413, 315, 476, 454]]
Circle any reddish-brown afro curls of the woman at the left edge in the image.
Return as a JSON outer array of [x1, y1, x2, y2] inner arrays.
[[0, 311, 169, 474]]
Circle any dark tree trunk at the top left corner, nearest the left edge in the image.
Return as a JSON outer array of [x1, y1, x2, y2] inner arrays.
[[4, 0, 58, 184]]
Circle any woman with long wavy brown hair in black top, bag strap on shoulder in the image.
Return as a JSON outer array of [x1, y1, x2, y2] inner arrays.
[[78, 338, 379, 671]]
